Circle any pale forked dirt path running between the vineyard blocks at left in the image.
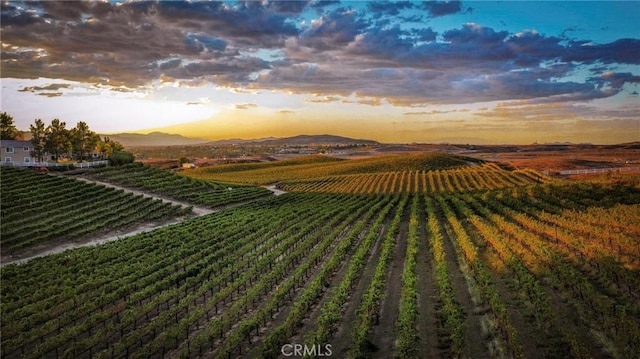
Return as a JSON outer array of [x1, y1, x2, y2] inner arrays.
[[0, 177, 287, 267]]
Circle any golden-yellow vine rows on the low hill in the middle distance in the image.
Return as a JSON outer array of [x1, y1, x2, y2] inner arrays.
[[278, 163, 548, 194]]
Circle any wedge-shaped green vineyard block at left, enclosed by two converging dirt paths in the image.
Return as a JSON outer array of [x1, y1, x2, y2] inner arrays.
[[0, 166, 191, 254]]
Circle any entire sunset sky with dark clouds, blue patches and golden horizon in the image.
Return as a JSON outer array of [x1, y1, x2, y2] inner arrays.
[[0, 0, 640, 144]]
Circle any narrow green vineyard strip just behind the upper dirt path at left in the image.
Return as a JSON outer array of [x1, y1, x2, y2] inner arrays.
[[90, 162, 270, 208]]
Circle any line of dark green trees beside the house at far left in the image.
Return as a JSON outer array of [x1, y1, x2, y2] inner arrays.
[[0, 112, 134, 164]]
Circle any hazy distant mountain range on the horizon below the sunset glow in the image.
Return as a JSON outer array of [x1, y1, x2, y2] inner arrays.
[[101, 132, 378, 147]]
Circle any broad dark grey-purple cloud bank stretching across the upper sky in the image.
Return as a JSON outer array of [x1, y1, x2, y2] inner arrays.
[[0, 1, 640, 107]]
